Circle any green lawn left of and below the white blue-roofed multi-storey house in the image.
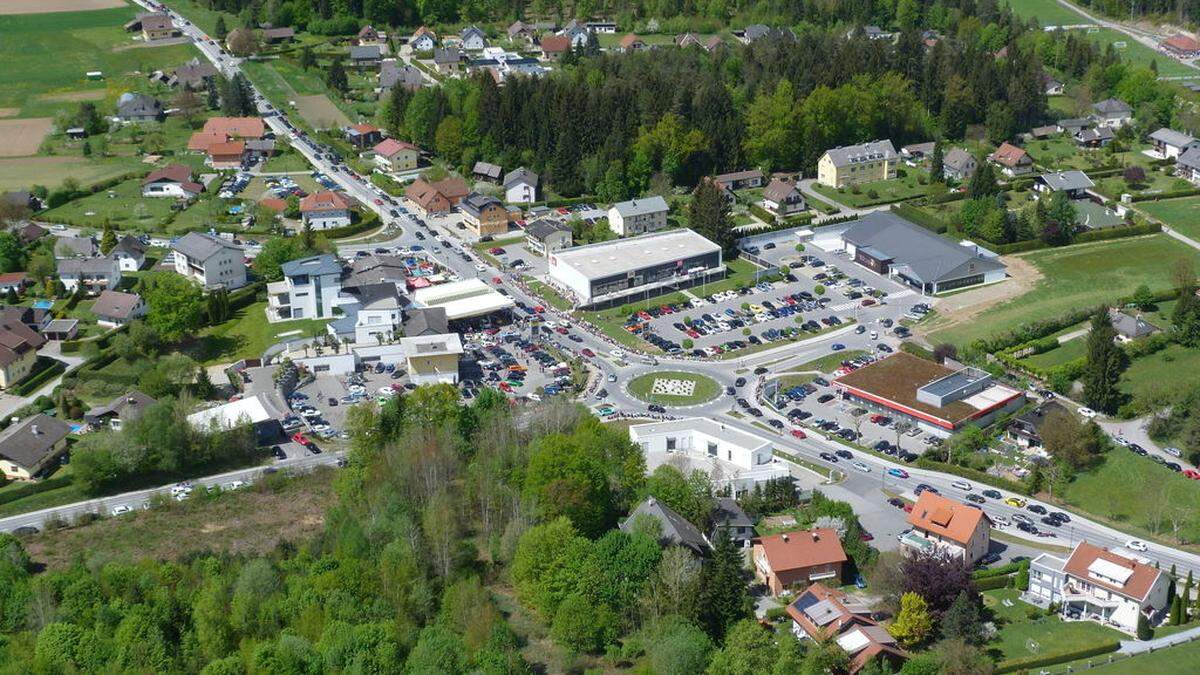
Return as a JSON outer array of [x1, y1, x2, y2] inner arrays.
[[187, 300, 328, 365]]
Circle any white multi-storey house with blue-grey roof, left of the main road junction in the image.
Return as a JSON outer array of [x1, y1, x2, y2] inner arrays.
[[266, 253, 342, 321]]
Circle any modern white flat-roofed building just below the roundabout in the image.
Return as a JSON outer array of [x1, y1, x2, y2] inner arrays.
[[629, 417, 790, 492]]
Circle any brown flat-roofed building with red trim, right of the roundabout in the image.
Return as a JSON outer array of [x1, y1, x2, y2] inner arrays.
[[833, 352, 1025, 438]]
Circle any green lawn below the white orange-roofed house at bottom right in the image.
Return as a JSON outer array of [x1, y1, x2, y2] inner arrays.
[[983, 589, 1127, 665]]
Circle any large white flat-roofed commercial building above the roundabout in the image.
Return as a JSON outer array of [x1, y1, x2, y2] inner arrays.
[[550, 229, 725, 307]]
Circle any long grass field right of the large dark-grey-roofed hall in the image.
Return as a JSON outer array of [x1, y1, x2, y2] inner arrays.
[[930, 234, 1200, 346]]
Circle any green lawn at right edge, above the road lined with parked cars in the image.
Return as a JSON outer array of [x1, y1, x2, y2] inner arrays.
[[1061, 448, 1200, 544]]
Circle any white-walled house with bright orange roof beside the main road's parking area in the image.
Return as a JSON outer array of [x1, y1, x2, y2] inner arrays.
[[900, 490, 991, 565]]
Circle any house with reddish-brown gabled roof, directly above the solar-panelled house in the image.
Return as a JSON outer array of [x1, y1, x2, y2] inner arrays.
[[751, 527, 850, 596]]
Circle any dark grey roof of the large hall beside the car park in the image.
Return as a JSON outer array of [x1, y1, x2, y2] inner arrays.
[[842, 211, 1004, 283]]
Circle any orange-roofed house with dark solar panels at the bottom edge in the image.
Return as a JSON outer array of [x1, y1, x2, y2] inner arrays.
[[787, 583, 908, 675]]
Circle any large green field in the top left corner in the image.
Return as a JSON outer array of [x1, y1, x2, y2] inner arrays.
[[0, 6, 198, 118]]
